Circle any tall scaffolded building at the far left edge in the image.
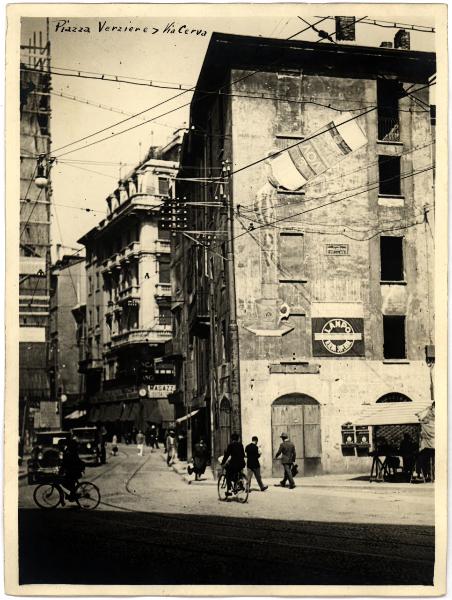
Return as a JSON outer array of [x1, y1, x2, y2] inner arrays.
[[19, 33, 52, 445]]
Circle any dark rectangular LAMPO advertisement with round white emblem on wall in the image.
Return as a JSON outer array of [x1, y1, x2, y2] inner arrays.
[[312, 317, 364, 357]]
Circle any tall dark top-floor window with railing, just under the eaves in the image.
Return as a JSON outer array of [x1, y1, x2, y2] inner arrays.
[[377, 79, 403, 142]]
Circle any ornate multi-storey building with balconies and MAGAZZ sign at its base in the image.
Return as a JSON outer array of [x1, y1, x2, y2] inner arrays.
[[77, 143, 178, 437]]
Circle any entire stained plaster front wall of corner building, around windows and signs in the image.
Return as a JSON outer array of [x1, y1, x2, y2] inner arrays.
[[231, 71, 433, 475]]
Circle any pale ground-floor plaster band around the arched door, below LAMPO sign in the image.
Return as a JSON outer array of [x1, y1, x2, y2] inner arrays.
[[240, 359, 430, 477]]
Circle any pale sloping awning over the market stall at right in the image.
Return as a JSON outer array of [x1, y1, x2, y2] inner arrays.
[[353, 400, 431, 425]]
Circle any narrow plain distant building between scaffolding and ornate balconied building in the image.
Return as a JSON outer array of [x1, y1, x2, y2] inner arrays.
[[48, 245, 86, 428]]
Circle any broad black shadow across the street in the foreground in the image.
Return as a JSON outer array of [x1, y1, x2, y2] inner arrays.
[[19, 507, 435, 586]]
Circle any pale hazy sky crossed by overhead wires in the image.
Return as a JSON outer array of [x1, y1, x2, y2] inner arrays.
[[21, 4, 435, 249]]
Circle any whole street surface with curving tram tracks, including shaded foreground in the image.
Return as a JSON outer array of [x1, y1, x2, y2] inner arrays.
[[19, 446, 434, 585]]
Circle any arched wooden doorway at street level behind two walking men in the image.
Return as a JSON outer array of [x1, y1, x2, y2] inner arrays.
[[272, 393, 322, 477]]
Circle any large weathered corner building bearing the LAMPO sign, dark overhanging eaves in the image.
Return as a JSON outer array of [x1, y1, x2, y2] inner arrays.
[[167, 28, 435, 476]]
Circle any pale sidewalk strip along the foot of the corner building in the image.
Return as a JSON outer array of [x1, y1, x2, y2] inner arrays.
[[161, 453, 435, 494]]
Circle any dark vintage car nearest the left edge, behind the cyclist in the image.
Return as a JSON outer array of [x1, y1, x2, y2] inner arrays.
[[27, 431, 70, 484]]
